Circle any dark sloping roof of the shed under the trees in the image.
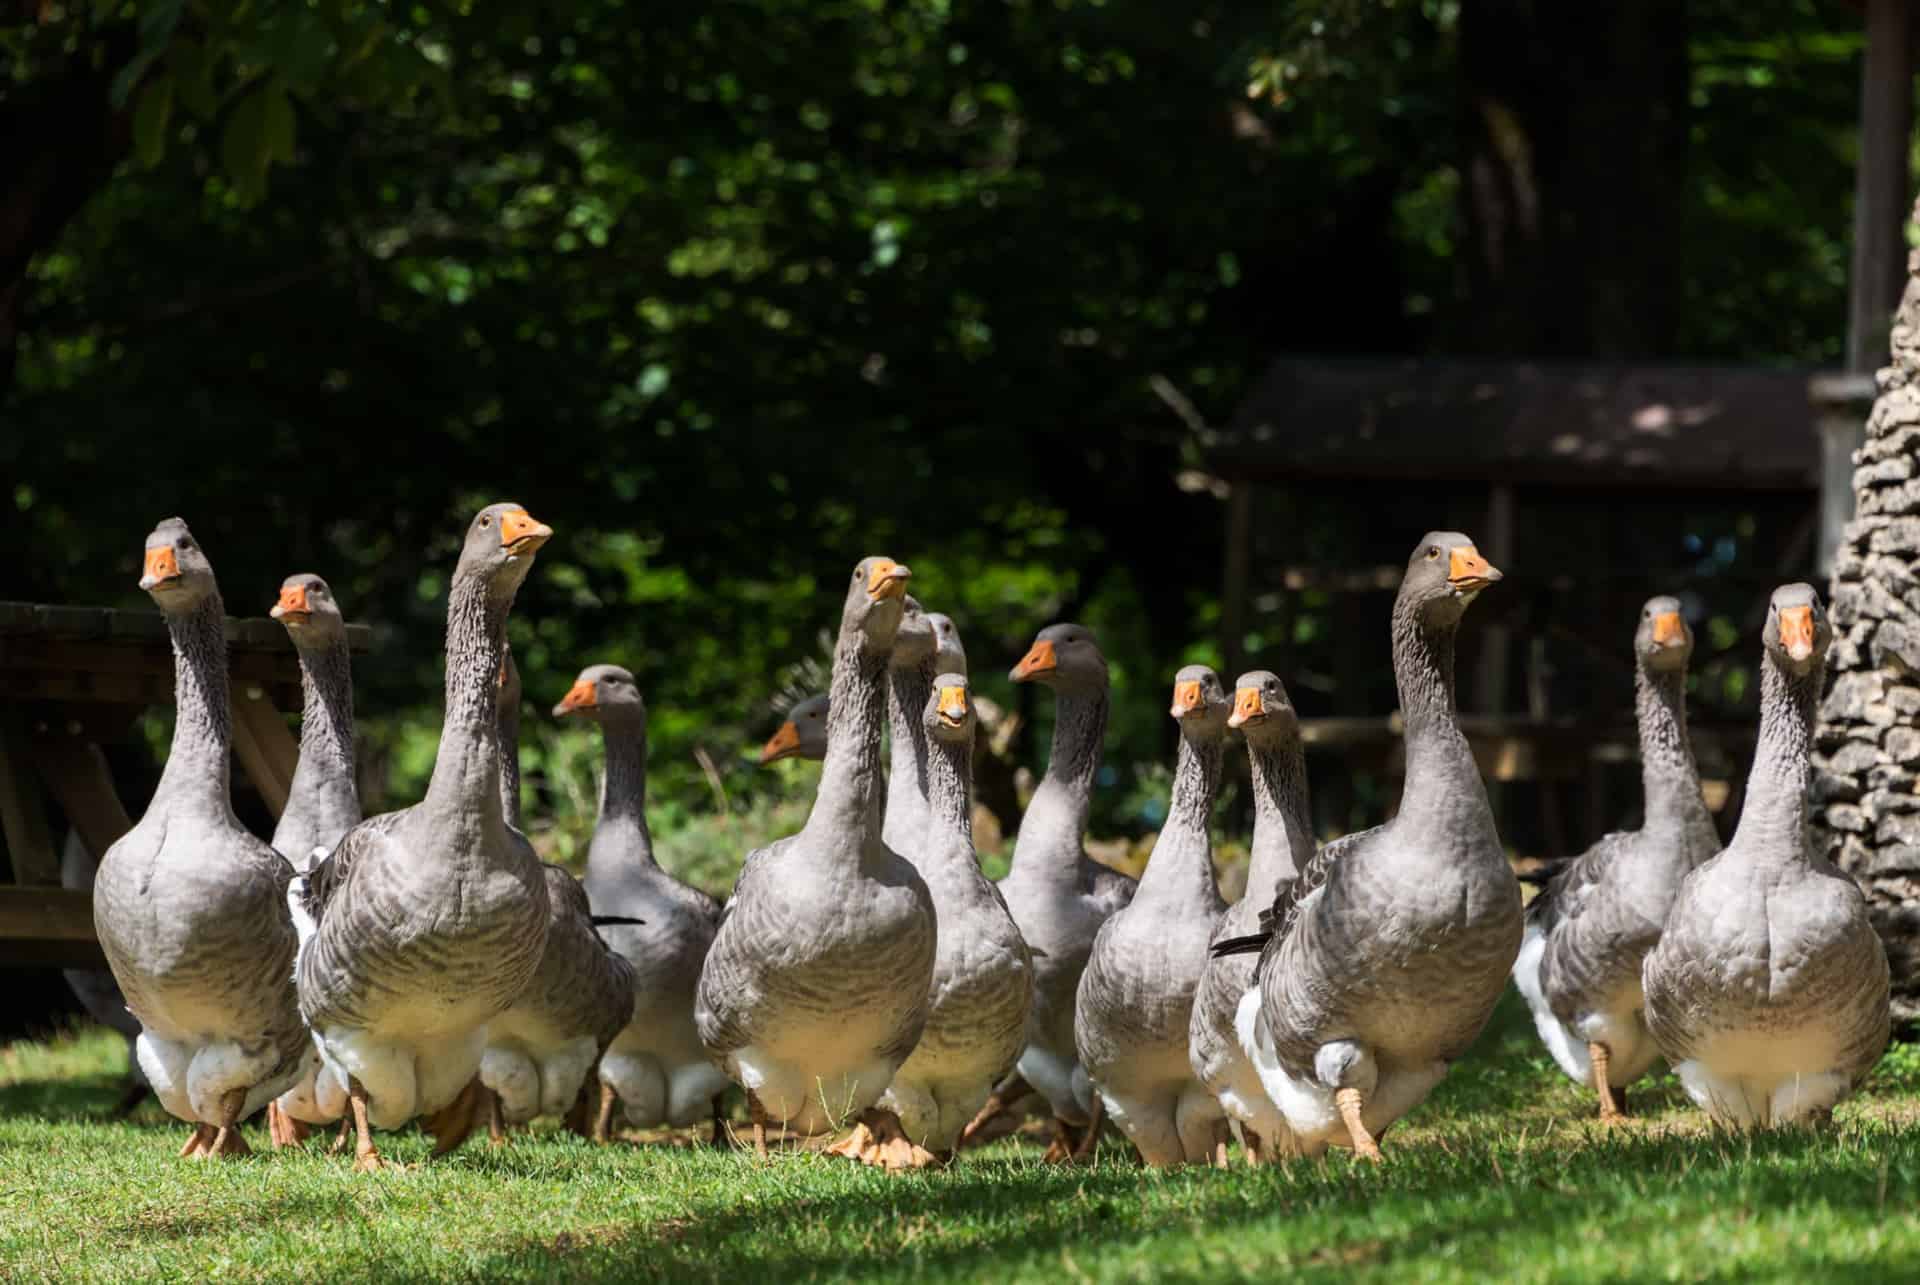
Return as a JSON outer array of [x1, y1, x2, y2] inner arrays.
[[1210, 357, 1820, 490]]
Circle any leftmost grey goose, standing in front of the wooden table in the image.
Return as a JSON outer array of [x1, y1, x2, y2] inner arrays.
[[94, 517, 307, 1160]]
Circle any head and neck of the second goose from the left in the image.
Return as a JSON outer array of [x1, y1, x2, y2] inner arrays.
[[271, 574, 361, 872]]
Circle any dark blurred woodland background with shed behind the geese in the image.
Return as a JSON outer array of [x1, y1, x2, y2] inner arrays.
[[0, 0, 1912, 1003]]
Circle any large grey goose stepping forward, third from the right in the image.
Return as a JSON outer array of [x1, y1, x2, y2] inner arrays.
[[1213, 532, 1521, 1160]]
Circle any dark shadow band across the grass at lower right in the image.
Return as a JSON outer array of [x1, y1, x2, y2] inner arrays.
[[441, 1127, 1920, 1281]]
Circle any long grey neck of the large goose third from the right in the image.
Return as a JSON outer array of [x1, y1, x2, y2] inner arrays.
[[1394, 595, 1486, 826]]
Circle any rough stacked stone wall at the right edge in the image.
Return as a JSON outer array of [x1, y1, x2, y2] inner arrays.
[[1812, 218, 1920, 1022]]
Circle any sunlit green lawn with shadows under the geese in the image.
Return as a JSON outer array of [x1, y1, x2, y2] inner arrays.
[[0, 995, 1920, 1283]]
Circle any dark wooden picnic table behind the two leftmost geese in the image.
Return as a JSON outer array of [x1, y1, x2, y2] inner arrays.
[[0, 601, 371, 966]]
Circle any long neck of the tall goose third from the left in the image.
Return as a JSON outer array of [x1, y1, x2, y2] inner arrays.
[[426, 574, 513, 830]]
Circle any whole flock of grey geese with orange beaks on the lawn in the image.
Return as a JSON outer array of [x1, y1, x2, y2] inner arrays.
[[94, 503, 1889, 1170]]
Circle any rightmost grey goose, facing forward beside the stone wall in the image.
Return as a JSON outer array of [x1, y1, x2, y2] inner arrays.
[[1642, 584, 1891, 1127]]
